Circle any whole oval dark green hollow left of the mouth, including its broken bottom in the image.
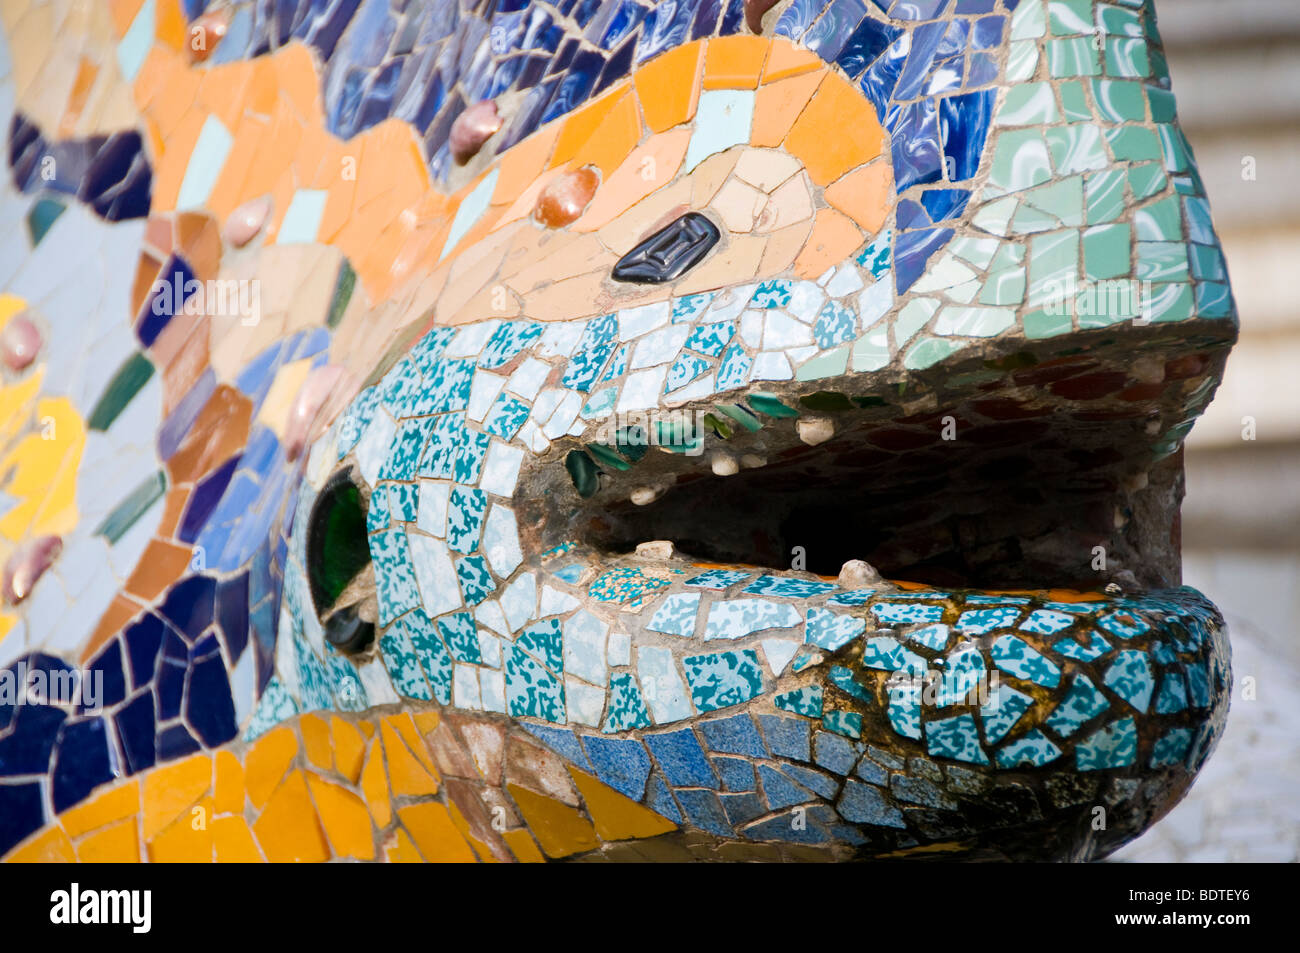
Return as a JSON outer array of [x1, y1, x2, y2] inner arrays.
[[307, 468, 376, 654]]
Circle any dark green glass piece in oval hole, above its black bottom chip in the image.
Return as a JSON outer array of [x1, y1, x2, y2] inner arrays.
[[307, 469, 371, 629]]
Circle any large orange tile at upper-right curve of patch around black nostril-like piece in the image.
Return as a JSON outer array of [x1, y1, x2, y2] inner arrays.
[[785, 73, 884, 186]]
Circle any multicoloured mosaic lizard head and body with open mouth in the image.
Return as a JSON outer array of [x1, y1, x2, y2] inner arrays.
[[0, 0, 1236, 861]]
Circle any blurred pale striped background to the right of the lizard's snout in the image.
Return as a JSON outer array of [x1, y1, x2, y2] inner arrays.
[[1114, 0, 1300, 862]]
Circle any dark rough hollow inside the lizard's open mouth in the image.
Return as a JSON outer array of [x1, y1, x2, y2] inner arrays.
[[529, 329, 1223, 590]]
